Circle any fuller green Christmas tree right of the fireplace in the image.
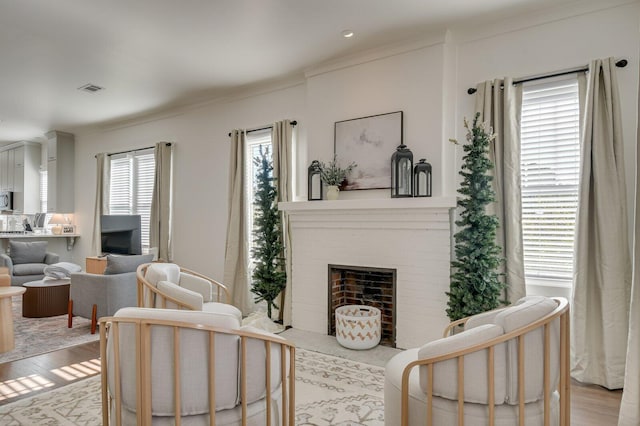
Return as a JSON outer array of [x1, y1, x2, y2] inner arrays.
[[447, 114, 505, 321]]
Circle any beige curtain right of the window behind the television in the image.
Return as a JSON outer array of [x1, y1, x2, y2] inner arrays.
[[149, 142, 174, 262]]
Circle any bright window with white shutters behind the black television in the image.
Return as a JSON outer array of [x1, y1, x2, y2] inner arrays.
[[109, 148, 156, 250]]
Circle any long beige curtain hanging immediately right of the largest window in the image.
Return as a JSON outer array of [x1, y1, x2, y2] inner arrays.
[[571, 58, 637, 390]]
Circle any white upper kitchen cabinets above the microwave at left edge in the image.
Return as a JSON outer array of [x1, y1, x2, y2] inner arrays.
[[0, 142, 41, 214]]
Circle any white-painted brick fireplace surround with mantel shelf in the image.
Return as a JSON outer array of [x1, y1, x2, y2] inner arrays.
[[279, 197, 456, 348]]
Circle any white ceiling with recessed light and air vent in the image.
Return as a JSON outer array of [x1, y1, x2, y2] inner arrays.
[[0, 0, 575, 142]]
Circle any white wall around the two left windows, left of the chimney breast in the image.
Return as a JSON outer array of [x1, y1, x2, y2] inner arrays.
[[75, 85, 306, 280]]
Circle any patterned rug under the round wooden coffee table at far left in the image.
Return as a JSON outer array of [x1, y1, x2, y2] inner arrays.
[[0, 297, 100, 364]]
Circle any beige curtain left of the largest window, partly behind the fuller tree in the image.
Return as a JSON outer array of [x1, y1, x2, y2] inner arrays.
[[475, 77, 526, 302]]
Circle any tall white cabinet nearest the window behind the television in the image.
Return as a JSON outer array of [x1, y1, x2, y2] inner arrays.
[[46, 130, 75, 213]]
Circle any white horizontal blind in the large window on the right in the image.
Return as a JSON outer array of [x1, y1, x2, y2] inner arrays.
[[521, 77, 580, 286]]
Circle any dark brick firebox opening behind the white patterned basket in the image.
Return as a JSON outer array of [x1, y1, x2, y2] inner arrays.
[[327, 265, 396, 348]]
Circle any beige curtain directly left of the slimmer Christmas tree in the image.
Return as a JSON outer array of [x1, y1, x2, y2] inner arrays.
[[223, 130, 253, 315]]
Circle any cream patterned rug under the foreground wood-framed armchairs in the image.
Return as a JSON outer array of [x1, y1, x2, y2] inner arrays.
[[0, 349, 384, 426]]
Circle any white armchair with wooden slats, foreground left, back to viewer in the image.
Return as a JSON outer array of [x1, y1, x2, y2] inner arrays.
[[100, 308, 295, 426]]
